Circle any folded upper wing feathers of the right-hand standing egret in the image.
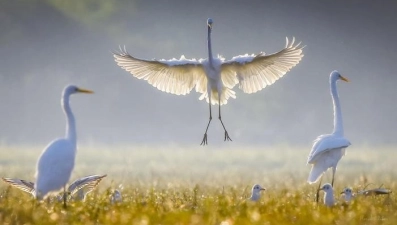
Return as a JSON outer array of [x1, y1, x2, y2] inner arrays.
[[307, 134, 350, 164]]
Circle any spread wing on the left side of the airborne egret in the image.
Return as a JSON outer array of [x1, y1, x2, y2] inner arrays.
[[113, 49, 205, 95]]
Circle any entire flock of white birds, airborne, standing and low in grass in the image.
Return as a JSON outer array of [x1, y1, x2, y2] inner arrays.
[[3, 19, 390, 207]]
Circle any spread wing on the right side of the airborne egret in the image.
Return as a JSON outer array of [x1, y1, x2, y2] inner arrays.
[[221, 38, 304, 93]]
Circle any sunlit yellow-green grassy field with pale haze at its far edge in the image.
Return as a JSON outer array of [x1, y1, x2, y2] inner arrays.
[[0, 146, 397, 225]]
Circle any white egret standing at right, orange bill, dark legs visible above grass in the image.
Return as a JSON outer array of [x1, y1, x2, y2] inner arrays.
[[307, 70, 350, 202]]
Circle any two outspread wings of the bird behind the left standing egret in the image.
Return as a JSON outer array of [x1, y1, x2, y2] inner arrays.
[[2, 175, 106, 200]]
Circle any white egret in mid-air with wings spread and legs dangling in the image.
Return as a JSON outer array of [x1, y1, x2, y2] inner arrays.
[[114, 18, 303, 145]]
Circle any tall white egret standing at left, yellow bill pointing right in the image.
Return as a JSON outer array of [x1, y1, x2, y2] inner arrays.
[[34, 85, 93, 207]]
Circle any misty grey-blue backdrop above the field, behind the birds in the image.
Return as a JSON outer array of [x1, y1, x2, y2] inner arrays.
[[0, 0, 397, 147]]
